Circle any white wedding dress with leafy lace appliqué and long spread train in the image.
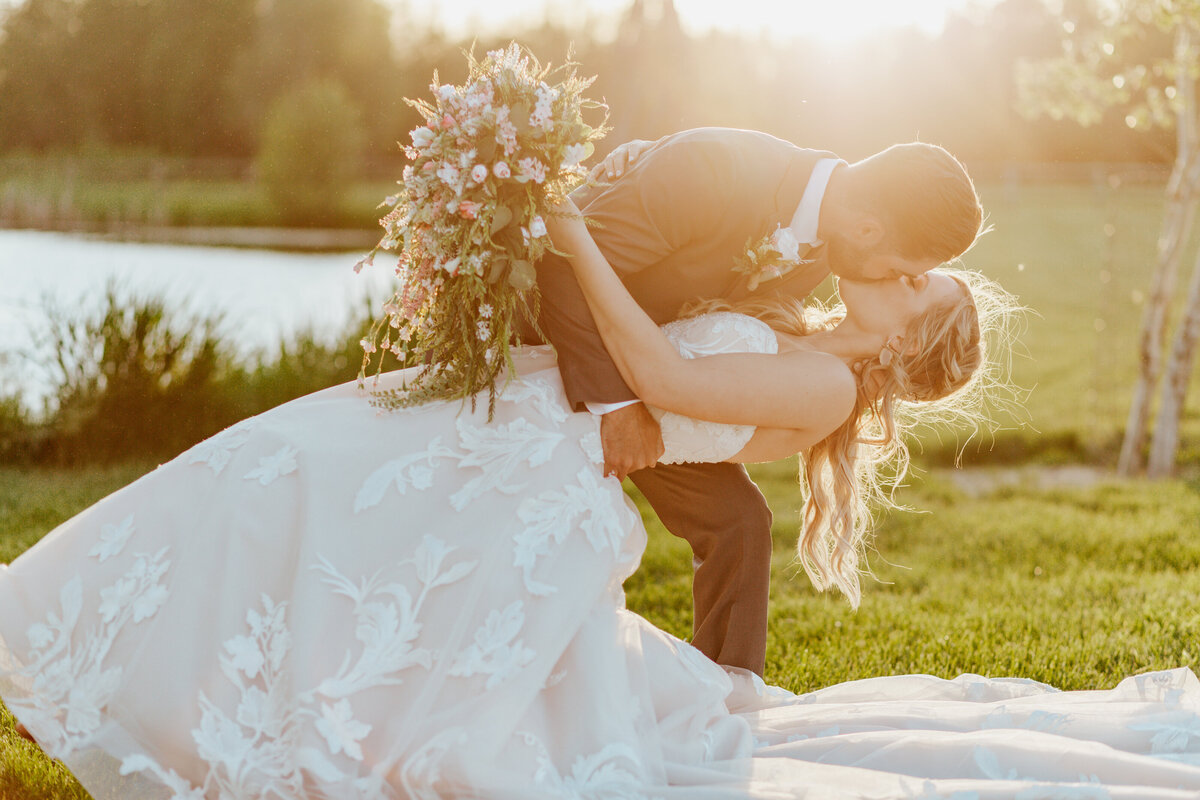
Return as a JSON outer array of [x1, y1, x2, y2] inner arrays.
[[0, 313, 1200, 800]]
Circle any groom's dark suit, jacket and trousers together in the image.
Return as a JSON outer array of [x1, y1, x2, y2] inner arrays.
[[538, 128, 834, 674]]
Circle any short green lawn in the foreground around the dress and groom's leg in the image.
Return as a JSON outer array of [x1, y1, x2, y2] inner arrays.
[[0, 462, 1200, 800]]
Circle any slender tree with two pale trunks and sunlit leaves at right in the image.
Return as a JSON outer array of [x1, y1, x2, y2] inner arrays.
[[1019, 0, 1200, 477]]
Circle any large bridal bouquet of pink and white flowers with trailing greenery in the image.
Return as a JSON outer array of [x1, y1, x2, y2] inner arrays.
[[355, 44, 605, 415]]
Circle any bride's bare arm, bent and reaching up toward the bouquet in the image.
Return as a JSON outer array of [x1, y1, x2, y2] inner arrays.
[[550, 200, 856, 435]]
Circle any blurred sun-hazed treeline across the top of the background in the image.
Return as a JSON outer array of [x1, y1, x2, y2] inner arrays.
[[0, 0, 1171, 167]]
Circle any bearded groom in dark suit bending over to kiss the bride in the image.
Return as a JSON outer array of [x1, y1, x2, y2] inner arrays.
[[538, 128, 983, 675]]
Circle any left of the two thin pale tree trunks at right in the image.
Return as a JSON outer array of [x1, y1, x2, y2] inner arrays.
[[1117, 22, 1200, 475]]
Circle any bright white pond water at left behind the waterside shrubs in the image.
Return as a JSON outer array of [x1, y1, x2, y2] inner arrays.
[[0, 230, 394, 398]]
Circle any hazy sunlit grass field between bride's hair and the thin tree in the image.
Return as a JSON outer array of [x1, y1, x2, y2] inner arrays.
[[936, 176, 1200, 464]]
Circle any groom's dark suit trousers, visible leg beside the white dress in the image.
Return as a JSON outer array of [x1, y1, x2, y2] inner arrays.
[[629, 463, 772, 675]]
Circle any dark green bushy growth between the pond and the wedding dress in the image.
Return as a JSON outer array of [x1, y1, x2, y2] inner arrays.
[[0, 291, 397, 465]]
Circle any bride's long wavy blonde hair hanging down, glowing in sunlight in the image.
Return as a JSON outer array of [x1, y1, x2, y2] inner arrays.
[[685, 267, 1021, 608]]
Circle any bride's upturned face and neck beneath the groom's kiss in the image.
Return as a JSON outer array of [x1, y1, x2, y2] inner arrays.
[[838, 270, 966, 338]]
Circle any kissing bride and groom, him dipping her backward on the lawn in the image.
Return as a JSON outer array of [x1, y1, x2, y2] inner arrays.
[[9, 128, 1200, 800]]
